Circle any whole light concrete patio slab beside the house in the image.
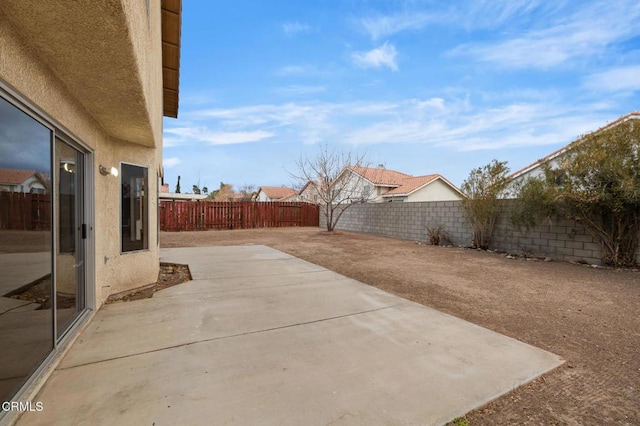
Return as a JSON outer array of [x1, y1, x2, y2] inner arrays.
[[20, 246, 562, 425]]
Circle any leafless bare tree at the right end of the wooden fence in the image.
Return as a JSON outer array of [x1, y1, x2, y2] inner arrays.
[[290, 145, 373, 232]]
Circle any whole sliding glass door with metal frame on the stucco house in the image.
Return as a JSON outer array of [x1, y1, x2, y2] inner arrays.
[[0, 90, 92, 408]]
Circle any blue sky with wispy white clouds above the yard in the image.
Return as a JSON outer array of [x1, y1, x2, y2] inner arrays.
[[163, 0, 640, 192]]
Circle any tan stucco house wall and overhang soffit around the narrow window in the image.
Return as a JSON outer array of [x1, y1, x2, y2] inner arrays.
[[0, 0, 171, 306]]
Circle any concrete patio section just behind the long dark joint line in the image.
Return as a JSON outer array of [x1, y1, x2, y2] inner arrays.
[[61, 277, 401, 368]]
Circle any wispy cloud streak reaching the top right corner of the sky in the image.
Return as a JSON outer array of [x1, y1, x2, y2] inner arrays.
[[451, 1, 640, 69]]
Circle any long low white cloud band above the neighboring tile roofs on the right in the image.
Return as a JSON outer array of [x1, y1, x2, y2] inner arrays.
[[345, 102, 607, 151]]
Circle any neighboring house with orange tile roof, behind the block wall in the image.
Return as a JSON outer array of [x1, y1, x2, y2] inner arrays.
[[332, 167, 464, 203]]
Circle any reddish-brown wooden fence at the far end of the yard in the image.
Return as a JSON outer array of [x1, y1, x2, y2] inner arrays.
[[158, 201, 320, 231]]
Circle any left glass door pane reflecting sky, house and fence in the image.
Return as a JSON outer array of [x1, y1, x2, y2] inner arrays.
[[0, 97, 53, 401]]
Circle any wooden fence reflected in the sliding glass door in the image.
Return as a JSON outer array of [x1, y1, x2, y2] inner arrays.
[[0, 192, 51, 231]]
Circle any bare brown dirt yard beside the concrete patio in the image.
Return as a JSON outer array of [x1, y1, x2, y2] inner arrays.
[[160, 228, 640, 425]]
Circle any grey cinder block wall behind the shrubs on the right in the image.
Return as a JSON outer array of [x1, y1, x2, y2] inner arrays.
[[320, 201, 640, 265]]
